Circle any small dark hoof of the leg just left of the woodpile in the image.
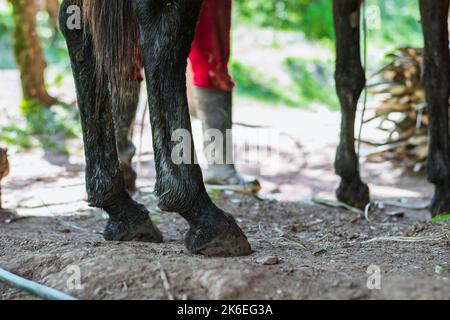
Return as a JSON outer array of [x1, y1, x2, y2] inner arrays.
[[336, 179, 370, 209]]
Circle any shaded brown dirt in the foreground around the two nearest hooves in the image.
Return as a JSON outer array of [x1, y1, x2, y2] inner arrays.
[[0, 193, 450, 299]]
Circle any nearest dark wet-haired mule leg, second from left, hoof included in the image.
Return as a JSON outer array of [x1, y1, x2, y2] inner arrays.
[[134, 0, 251, 256]]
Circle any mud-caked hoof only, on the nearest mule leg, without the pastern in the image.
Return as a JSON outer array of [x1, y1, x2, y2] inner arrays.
[[186, 213, 253, 257]]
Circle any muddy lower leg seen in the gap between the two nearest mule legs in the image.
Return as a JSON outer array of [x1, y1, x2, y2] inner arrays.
[[112, 81, 141, 192]]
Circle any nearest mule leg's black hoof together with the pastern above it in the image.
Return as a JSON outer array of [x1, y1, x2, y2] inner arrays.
[[186, 203, 253, 257]]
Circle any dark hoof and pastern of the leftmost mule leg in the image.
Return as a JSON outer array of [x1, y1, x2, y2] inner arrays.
[[103, 199, 163, 243]]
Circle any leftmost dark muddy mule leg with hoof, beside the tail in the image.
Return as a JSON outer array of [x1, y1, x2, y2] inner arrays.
[[60, 0, 162, 242]]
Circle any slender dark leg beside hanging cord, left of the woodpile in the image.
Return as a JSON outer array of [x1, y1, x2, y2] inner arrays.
[[333, 0, 370, 208]]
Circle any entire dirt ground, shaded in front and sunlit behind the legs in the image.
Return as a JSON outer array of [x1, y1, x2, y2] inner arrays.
[[0, 68, 450, 299]]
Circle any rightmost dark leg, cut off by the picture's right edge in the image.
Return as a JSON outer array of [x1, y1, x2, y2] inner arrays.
[[420, 0, 450, 215]]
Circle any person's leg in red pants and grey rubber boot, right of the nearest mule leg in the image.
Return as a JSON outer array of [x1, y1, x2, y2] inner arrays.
[[189, 0, 260, 191]]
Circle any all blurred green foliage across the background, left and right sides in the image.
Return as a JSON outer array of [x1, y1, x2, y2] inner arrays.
[[0, 0, 423, 147]]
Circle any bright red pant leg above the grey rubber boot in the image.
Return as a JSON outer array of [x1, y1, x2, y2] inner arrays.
[[189, 0, 234, 92]]
